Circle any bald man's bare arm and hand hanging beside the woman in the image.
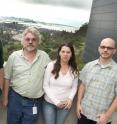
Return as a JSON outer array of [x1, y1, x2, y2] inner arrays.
[[77, 82, 85, 118]]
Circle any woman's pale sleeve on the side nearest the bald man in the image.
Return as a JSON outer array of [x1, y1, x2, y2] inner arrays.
[[69, 77, 78, 100]]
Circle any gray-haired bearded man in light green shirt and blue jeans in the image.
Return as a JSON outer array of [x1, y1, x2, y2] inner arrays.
[[3, 27, 50, 124]]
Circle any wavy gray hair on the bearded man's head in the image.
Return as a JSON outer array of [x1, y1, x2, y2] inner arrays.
[[22, 27, 41, 43]]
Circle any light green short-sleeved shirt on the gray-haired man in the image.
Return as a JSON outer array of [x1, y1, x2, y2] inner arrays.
[[5, 50, 50, 98]]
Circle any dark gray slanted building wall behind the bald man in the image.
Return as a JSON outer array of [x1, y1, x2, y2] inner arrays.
[[84, 0, 117, 62]]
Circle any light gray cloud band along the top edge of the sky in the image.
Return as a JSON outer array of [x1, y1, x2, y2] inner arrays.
[[20, 0, 92, 9]]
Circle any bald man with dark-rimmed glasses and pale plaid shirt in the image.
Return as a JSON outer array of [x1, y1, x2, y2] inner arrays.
[[77, 38, 117, 124]]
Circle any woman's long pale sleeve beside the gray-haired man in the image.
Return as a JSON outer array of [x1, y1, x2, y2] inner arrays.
[[43, 62, 60, 105]]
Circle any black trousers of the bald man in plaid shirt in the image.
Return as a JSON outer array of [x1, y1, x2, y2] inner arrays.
[[77, 115, 111, 124]]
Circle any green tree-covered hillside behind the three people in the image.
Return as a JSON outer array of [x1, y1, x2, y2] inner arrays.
[[0, 23, 87, 69]]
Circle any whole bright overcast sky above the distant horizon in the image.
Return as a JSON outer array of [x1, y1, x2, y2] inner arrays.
[[0, 0, 93, 27]]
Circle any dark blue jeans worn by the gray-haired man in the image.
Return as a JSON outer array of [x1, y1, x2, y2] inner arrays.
[[7, 89, 43, 124]]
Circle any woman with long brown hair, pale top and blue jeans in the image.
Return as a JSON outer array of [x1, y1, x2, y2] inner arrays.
[[43, 43, 78, 124]]
